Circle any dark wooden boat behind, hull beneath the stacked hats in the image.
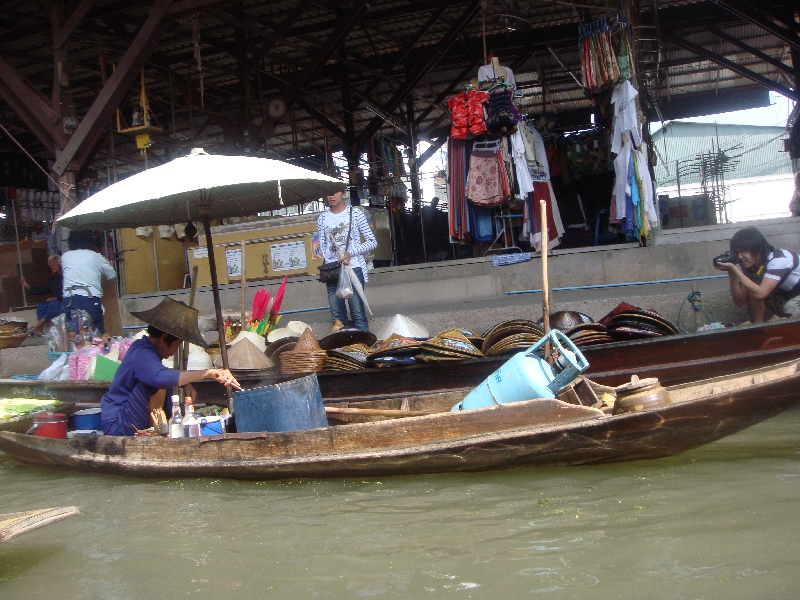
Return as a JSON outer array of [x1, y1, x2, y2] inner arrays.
[[6, 319, 800, 404]]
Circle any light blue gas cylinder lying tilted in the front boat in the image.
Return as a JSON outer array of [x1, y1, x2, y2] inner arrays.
[[453, 329, 589, 411]]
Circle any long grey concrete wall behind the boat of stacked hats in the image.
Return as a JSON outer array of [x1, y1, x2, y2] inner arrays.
[[121, 218, 800, 329]]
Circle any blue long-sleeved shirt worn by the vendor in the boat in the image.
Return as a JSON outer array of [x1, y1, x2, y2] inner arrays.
[[100, 337, 180, 426]]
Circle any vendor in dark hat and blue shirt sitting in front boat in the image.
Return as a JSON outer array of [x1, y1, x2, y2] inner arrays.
[[100, 298, 239, 435]]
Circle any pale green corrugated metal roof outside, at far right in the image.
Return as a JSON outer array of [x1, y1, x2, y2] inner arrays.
[[653, 121, 792, 186]]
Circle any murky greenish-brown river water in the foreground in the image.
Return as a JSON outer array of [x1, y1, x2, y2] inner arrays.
[[0, 409, 800, 600]]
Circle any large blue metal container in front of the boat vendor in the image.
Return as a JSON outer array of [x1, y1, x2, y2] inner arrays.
[[233, 373, 328, 433]]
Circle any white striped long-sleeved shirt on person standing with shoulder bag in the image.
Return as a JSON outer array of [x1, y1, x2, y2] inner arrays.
[[317, 206, 378, 282]]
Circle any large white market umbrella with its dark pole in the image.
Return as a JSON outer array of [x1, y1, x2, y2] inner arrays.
[[57, 149, 344, 382]]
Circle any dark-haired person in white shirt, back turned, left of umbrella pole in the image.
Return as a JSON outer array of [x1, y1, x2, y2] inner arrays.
[[61, 231, 117, 333]]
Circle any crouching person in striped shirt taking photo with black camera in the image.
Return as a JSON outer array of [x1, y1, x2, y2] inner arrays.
[[714, 227, 800, 323]]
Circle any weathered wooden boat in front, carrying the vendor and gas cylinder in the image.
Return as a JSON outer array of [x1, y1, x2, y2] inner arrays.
[[0, 360, 800, 480]]
